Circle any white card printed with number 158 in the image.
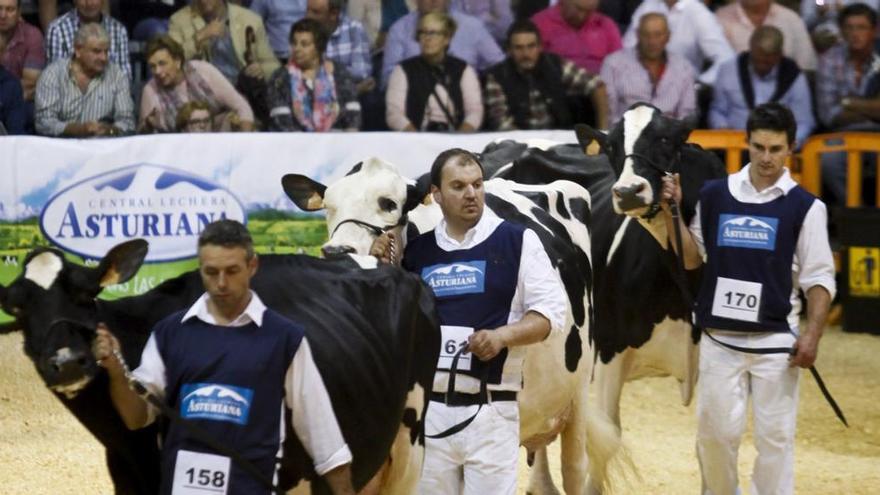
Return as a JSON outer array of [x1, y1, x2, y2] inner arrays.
[[171, 450, 229, 495]]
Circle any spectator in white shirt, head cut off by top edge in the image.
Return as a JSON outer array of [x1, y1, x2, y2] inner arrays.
[[623, 0, 735, 86]]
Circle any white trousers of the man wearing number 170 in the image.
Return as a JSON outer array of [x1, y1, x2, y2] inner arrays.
[[697, 336, 800, 495]]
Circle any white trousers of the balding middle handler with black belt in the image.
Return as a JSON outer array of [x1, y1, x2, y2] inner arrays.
[[419, 401, 519, 495]]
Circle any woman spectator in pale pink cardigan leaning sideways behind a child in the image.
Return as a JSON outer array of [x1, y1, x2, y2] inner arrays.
[[138, 35, 254, 133]]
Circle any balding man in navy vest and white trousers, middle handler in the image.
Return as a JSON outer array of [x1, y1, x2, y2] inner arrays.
[[371, 149, 566, 495]]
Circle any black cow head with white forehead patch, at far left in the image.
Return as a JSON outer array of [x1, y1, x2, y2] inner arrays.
[[0, 239, 147, 397]]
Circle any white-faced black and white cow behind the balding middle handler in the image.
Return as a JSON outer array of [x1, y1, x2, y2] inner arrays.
[[282, 158, 619, 494]]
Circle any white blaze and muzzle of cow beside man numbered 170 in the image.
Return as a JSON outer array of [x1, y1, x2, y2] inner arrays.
[[612, 106, 656, 216]]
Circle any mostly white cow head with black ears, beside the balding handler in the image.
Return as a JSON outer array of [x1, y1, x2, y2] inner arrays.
[[281, 158, 428, 257]]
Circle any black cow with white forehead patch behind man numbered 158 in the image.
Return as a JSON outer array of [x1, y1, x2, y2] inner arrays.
[[0, 241, 440, 495]]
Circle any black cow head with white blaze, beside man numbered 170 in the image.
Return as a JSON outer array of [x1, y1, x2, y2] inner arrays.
[[575, 103, 691, 217]]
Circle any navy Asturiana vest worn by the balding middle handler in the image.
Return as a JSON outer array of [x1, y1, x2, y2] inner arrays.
[[403, 222, 525, 384]]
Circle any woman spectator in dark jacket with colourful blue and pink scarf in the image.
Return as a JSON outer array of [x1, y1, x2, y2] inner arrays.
[[269, 19, 361, 132]]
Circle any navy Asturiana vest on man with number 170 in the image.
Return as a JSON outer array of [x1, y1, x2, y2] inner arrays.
[[697, 178, 816, 332]]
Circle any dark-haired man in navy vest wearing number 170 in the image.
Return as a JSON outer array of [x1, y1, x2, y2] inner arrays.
[[662, 103, 836, 495]]
